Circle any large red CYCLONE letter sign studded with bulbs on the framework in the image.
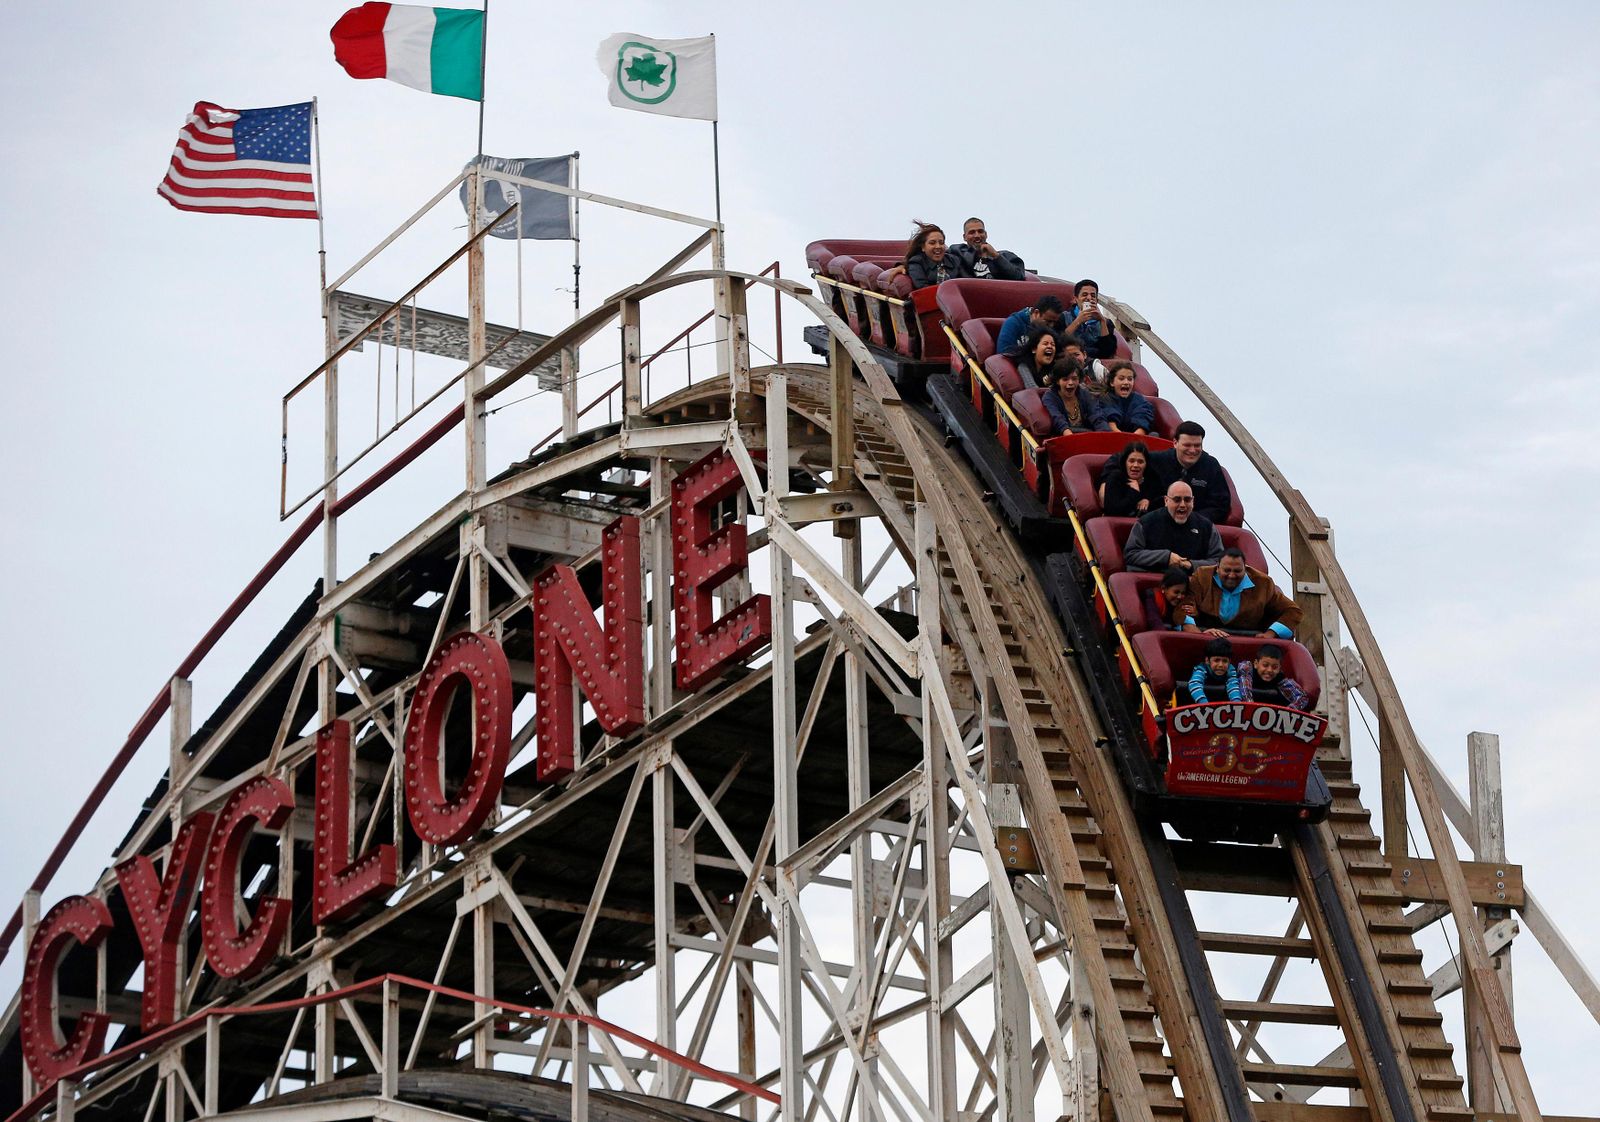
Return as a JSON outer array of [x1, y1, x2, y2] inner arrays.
[[19, 450, 771, 1085]]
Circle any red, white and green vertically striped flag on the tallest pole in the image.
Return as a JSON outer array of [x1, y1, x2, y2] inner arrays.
[[330, 3, 483, 101]]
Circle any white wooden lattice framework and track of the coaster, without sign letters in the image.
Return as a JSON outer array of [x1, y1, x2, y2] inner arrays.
[[0, 181, 1600, 1122]]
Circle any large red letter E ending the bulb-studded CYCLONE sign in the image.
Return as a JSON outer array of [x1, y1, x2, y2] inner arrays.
[[672, 451, 773, 690]]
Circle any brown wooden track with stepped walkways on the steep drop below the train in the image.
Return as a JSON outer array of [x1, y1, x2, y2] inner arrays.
[[761, 323, 1472, 1122]]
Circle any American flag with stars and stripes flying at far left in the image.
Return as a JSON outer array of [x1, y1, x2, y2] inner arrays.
[[155, 101, 317, 218]]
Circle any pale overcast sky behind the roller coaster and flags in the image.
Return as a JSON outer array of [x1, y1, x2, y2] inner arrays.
[[0, 0, 1600, 1112]]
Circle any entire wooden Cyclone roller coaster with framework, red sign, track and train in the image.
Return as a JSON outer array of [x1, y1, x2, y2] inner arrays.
[[0, 171, 1600, 1122]]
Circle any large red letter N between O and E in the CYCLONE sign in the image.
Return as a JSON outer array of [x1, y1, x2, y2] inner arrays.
[[533, 515, 645, 779]]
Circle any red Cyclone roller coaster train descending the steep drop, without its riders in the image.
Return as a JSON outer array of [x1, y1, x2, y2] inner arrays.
[[806, 254, 1331, 842]]
